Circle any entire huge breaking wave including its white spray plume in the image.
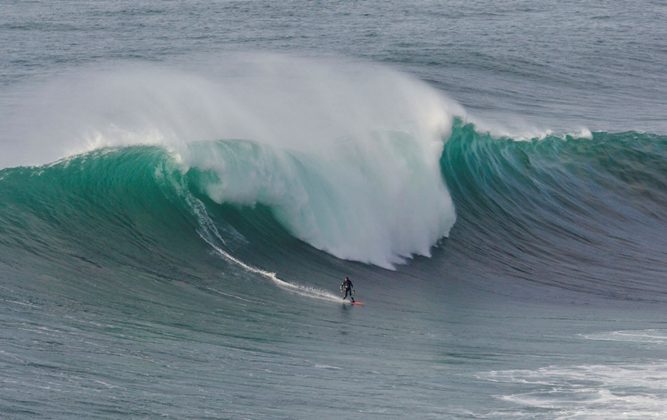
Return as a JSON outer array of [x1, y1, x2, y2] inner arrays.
[[0, 56, 667, 300]]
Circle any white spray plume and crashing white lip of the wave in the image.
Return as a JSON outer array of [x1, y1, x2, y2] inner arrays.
[[3, 54, 462, 268]]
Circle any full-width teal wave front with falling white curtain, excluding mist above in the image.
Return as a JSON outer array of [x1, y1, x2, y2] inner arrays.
[[0, 120, 667, 300]]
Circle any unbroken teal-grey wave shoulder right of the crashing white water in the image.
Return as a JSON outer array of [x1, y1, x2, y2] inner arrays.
[[441, 122, 667, 300]]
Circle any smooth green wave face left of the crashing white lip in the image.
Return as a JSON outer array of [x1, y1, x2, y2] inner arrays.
[[0, 147, 206, 278]]
